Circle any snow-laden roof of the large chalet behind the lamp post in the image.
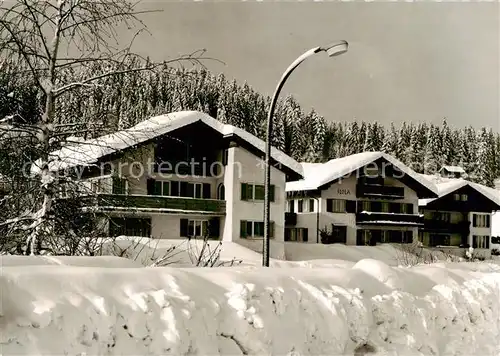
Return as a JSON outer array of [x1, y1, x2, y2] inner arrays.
[[32, 111, 302, 176]]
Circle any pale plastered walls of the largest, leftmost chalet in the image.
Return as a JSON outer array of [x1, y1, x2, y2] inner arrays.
[[80, 140, 286, 246]]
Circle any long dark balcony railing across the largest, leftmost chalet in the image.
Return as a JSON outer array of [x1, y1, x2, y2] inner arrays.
[[81, 194, 226, 213]]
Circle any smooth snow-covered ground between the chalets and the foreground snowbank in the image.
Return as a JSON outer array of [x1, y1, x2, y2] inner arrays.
[[98, 237, 472, 267]]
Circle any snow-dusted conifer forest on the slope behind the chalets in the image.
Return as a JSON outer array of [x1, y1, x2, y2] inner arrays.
[[0, 61, 500, 186]]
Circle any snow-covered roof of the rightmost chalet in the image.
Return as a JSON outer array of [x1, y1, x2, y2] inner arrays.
[[418, 174, 500, 206]]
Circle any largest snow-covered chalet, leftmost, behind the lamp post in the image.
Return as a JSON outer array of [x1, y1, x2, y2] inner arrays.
[[35, 111, 303, 247]]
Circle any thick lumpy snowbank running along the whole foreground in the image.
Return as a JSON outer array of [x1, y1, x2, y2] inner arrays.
[[0, 259, 500, 355]]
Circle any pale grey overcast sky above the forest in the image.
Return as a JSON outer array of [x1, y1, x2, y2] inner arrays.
[[131, 0, 500, 130]]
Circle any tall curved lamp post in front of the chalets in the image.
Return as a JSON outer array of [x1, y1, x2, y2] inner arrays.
[[262, 41, 349, 267]]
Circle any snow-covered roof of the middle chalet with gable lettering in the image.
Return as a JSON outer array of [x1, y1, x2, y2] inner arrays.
[[286, 152, 436, 197]]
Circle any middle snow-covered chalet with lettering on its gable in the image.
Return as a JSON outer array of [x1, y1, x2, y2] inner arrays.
[[285, 152, 437, 245]]
